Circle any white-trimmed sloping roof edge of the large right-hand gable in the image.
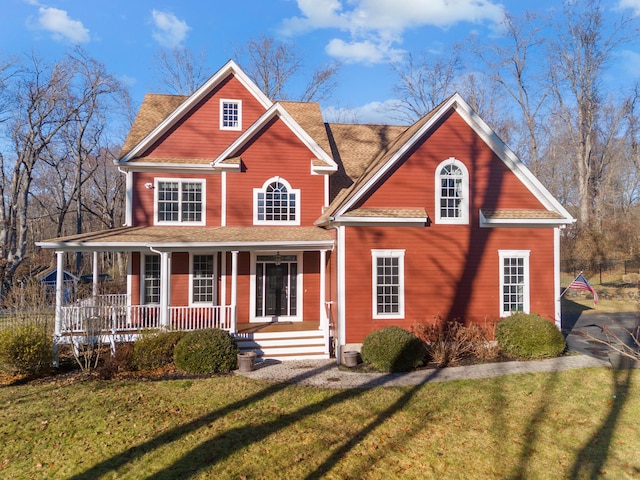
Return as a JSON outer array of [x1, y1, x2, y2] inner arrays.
[[316, 93, 574, 225]]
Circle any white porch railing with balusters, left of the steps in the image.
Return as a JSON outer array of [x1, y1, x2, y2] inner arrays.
[[57, 295, 235, 335]]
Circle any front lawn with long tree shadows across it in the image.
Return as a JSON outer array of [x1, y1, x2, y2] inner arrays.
[[0, 368, 640, 479]]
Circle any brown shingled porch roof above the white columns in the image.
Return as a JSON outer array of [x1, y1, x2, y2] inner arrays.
[[36, 226, 334, 252]]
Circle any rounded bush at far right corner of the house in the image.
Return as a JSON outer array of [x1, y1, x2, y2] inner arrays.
[[496, 313, 566, 359]]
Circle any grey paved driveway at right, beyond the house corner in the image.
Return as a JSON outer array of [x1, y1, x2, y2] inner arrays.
[[562, 312, 640, 359]]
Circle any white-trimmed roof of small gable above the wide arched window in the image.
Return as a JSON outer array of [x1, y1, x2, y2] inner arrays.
[[211, 102, 338, 173]]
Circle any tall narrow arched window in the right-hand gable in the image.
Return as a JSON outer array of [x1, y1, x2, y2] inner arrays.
[[435, 158, 469, 224]]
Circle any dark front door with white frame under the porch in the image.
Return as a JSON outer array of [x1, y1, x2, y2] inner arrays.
[[255, 255, 298, 321]]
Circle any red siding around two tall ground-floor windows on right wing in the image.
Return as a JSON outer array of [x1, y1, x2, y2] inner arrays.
[[345, 225, 555, 343]]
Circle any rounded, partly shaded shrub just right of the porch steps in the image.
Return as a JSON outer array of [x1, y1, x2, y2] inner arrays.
[[361, 327, 425, 372]]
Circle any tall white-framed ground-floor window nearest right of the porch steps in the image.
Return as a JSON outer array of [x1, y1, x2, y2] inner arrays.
[[371, 250, 404, 318]]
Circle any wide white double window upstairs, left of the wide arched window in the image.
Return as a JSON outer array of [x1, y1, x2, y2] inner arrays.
[[155, 179, 205, 225]]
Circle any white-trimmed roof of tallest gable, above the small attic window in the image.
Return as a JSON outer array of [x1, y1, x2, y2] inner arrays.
[[117, 60, 273, 164]]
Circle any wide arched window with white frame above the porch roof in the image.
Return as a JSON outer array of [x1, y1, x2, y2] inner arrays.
[[253, 177, 300, 225]]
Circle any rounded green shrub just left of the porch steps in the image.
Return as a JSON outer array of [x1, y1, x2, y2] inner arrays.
[[173, 329, 238, 375]]
